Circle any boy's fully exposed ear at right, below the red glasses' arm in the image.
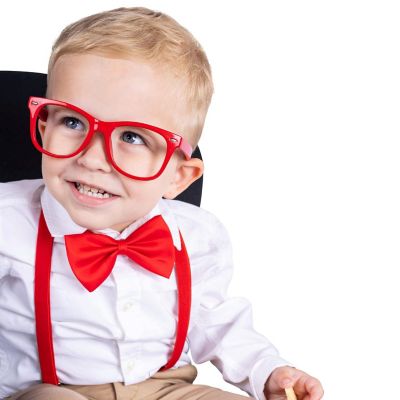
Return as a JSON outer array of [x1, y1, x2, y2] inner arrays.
[[163, 158, 204, 199]]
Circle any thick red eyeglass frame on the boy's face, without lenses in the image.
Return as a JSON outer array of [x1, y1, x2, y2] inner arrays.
[[28, 96, 193, 181]]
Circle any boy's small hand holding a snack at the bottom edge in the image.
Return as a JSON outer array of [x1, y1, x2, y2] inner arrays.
[[264, 367, 324, 400]]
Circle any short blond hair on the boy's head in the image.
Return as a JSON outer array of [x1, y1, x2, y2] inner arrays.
[[48, 7, 213, 145]]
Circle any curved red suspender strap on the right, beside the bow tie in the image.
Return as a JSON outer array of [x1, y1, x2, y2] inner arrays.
[[160, 232, 192, 371]]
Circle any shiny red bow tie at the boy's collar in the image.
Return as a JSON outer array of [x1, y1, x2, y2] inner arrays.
[[64, 215, 175, 292]]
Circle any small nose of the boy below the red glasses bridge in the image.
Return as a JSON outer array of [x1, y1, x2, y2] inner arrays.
[[77, 132, 112, 172]]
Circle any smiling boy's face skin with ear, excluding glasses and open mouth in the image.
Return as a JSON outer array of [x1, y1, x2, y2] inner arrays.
[[42, 54, 202, 231]]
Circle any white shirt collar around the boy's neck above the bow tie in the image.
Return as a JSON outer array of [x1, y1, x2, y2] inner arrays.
[[40, 186, 181, 250]]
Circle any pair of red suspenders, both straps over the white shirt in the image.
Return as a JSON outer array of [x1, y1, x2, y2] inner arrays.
[[35, 211, 192, 385]]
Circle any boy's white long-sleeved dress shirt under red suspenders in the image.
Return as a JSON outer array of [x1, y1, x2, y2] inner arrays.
[[0, 179, 288, 399]]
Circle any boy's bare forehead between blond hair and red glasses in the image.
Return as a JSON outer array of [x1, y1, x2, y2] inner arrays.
[[47, 54, 186, 134]]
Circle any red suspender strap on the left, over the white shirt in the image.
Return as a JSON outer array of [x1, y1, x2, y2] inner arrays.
[[35, 211, 59, 385]]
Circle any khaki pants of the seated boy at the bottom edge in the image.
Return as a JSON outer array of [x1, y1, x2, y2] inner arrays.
[[7, 365, 253, 400]]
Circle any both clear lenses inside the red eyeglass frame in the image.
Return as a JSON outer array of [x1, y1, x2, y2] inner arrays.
[[36, 105, 167, 178]]
